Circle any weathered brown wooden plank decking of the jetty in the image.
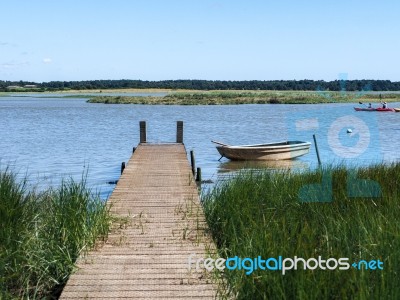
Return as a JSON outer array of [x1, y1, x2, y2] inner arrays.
[[61, 144, 216, 299]]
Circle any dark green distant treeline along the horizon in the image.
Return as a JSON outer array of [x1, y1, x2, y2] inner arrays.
[[0, 80, 400, 91]]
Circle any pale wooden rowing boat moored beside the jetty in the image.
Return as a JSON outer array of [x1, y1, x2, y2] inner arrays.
[[217, 141, 311, 160]]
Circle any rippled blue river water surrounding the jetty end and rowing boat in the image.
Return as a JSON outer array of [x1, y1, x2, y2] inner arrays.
[[0, 96, 400, 198]]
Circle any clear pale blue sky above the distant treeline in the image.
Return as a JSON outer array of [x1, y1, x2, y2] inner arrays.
[[0, 0, 400, 82]]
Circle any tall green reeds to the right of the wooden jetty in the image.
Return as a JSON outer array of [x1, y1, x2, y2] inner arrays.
[[203, 164, 400, 299]]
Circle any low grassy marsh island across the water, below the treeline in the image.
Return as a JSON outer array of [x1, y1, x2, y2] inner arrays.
[[88, 91, 400, 105]]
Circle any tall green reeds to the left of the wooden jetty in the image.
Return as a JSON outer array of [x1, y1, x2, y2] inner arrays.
[[0, 171, 111, 299]]
